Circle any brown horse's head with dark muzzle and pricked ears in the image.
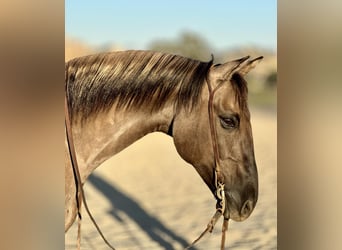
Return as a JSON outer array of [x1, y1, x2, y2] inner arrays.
[[172, 57, 262, 221]]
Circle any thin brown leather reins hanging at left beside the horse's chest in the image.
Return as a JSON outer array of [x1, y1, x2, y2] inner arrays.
[[64, 92, 115, 250]]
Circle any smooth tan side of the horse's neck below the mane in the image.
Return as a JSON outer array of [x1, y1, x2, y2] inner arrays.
[[72, 105, 174, 182]]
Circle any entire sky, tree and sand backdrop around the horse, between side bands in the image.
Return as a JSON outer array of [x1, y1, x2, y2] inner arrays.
[[65, 0, 277, 249]]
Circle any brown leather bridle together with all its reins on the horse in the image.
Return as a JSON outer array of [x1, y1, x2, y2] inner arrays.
[[64, 61, 234, 250]]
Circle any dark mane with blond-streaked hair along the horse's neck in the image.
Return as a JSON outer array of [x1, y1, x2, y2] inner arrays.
[[65, 51, 212, 120]]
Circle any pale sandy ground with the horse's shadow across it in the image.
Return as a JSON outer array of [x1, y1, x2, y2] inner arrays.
[[65, 109, 277, 250]]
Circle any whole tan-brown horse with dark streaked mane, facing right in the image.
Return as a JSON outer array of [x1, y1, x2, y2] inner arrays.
[[64, 50, 262, 248]]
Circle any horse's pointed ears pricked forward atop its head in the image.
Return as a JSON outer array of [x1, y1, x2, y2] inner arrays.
[[212, 56, 263, 79]]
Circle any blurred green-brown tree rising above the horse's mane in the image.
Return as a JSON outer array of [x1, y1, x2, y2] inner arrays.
[[149, 32, 211, 61]]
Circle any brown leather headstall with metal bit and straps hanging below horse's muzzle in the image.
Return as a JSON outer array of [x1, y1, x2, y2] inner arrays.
[[185, 71, 229, 250]]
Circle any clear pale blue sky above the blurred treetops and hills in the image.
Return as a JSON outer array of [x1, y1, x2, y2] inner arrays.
[[65, 0, 277, 50]]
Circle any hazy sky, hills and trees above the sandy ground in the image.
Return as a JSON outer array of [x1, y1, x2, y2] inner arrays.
[[65, 0, 277, 110]]
